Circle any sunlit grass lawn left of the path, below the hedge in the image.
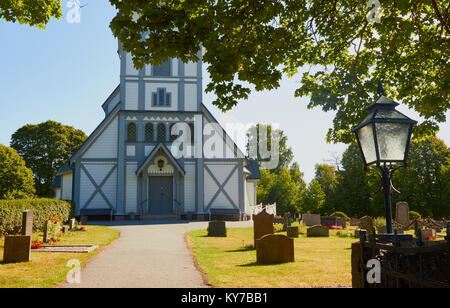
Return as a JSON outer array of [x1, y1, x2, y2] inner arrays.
[[0, 226, 119, 288]]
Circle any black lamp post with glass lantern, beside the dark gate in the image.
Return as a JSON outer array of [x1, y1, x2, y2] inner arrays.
[[352, 82, 417, 233]]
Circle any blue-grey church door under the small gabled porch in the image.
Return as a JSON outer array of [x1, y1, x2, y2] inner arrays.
[[148, 176, 173, 214]]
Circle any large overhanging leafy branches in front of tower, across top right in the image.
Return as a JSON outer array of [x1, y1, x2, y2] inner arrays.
[[110, 0, 450, 143]]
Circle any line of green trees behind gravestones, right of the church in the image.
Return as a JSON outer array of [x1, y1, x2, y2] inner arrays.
[[253, 125, 450, 219]]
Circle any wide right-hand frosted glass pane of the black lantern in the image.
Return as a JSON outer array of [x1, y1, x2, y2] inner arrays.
[[375, 123, 409, 161]]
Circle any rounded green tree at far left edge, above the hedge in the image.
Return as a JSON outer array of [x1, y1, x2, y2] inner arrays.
[[0, 144, 35, 199]]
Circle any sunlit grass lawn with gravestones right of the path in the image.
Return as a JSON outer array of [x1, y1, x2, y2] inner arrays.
[[188, 226, 357, 288]]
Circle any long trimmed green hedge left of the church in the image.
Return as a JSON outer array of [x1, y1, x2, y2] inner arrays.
[[0, 199, 74, 236]]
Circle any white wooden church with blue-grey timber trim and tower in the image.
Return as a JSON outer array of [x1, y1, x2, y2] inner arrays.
[[52, 39, 260, 219]]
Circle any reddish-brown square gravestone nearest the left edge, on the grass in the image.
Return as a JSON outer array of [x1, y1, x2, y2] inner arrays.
[[3, 235, 31, 262]]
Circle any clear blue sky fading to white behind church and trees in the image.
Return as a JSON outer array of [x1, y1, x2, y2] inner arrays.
[[0, 0, 450, 181]]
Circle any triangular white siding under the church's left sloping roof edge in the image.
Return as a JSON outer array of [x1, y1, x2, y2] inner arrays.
[[83, 117, 118, 158]]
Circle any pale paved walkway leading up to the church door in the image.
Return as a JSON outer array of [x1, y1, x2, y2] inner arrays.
[[61, 220, 251, 288]]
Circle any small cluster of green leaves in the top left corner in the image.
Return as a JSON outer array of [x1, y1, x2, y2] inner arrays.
[[0, 0, 62, 29]]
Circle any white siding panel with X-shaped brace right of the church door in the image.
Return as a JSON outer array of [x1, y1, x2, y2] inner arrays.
[[204, 163, 239, 208]]
